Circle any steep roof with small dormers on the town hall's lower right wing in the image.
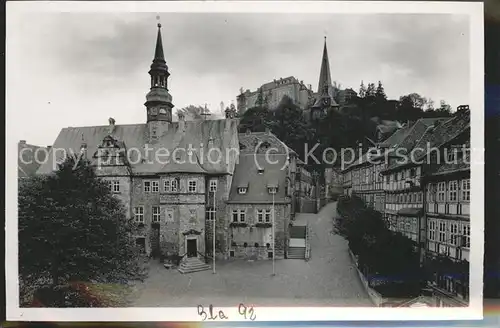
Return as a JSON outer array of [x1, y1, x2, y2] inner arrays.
[[228, 154, 289, 204]]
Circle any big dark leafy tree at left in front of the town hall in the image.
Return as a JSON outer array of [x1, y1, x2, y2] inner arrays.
[[19, 157, 139, 292]]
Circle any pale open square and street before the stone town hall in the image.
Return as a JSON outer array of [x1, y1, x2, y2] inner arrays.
[[133, 203, 373, 307]]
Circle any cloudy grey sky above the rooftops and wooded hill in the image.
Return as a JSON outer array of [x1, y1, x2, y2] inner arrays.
[[7, 13, 469, 145]]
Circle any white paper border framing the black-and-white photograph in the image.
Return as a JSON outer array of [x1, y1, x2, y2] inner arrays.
[[5, 1, 484, 321]]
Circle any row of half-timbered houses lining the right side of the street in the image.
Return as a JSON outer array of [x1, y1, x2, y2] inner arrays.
[[330, 106, 471, 306]]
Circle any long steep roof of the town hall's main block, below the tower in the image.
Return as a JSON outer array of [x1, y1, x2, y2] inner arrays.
[[37, 119, 238, 174]]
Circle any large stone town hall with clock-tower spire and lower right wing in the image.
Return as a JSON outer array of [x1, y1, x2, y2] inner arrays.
[[37, 24, 312, 270]]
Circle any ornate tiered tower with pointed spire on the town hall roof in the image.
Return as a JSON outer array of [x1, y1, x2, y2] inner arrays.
[[144, 24, 174, 139]]
